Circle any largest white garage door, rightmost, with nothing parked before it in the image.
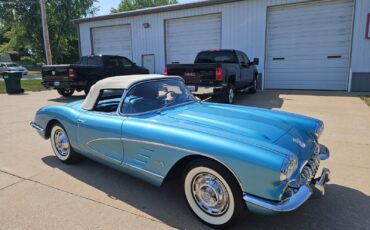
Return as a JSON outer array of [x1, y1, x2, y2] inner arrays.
[[265, 0, 353, 90]]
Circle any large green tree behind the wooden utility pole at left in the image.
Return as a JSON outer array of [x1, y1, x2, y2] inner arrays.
[[0, 0, 97, 64]]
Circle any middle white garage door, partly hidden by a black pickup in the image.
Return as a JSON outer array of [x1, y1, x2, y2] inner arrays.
[[166, 14, 221, 63]]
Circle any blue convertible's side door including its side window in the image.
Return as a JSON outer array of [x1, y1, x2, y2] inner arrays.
[[77, 90, 125, 165]]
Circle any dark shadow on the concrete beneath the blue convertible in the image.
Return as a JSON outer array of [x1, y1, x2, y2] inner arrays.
[[42, 156, 370, 230]]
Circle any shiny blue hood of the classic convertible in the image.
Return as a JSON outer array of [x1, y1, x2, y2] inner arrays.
[[168, 103, 292, 143]]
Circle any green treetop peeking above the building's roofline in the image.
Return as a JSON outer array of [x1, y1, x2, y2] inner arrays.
[[111, 0, 177, 13]]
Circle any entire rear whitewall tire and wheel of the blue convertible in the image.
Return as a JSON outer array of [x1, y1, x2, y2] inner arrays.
[[50, 123, 77, 163]]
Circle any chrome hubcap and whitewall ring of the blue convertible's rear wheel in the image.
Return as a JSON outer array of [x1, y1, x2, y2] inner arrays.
[[50, 126, 71, 161]]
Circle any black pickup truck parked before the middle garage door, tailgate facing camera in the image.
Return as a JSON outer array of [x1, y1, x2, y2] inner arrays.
[[165, 50, 259, 104]]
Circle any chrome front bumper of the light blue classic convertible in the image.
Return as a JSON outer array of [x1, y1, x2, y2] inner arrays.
[[243, 145, 330, 212]]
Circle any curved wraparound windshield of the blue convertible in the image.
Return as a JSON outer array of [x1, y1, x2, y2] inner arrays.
[[121, 79, 195, 114]]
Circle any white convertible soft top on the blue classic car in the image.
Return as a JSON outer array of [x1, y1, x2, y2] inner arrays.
[[82, 74, 181, 110]]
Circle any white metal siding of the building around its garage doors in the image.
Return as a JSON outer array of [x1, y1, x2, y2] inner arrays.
[[80, 0, 370, 90]]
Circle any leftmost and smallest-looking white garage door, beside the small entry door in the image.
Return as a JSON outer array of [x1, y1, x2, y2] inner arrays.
[[91, 25, 132, 59]]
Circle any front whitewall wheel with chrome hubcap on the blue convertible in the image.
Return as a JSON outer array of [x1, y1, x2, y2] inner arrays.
[[184, 160, 244, 227]]
